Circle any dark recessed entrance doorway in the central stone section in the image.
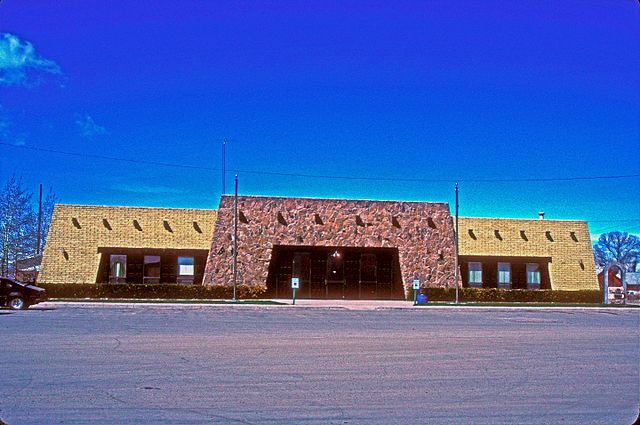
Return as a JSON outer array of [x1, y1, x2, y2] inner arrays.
[[267, 245, 404, 299]]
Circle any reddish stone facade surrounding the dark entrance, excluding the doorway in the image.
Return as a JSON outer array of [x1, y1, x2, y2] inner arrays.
[[203, 196, 455, 289]]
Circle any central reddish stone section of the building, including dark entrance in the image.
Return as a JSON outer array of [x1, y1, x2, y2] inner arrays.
[[204, 196, 455, 299]]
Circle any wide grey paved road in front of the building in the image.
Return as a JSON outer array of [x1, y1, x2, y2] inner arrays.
[[0, 304, 640, 425]]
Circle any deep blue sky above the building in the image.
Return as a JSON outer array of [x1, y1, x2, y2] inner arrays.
[[0, 0, 640, 235]]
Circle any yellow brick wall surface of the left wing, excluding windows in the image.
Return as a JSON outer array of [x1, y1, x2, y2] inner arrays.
[[38, 204, 216, 283]]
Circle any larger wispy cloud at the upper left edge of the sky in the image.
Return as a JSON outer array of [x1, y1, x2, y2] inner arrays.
[[0, 33, 62, 86]]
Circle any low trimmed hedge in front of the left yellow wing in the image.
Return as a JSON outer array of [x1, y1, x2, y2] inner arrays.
[[38, 283, 266, 300]]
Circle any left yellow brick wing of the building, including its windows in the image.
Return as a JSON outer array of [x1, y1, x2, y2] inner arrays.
[[38, 204, 216, 284]]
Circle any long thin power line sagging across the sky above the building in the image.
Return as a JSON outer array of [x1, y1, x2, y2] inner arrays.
[[0, 142, 640, 183]]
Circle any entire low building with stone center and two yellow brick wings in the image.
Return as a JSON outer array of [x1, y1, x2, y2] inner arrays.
[[38, 196, 598, 299]]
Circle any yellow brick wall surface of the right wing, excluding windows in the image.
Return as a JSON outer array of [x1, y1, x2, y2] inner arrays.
[[459, 217, 599, 290]]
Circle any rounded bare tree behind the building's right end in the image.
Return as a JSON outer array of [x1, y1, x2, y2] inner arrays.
[[593, 232, 640, 272]]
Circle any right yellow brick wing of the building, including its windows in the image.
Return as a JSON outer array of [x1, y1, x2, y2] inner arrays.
[[458, 215, 598, 290]]
